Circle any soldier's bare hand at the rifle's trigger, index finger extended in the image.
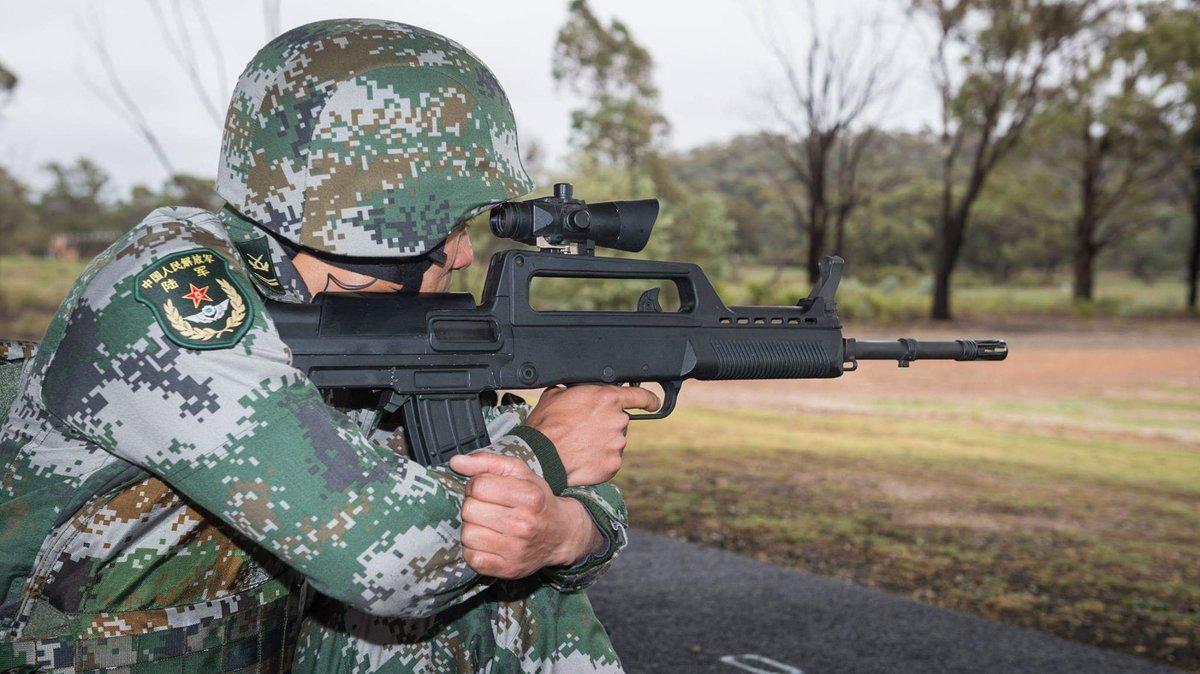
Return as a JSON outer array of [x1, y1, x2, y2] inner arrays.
[[526, 384, 660, 487]]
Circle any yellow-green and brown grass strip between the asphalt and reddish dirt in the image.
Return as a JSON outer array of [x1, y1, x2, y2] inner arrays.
[[618, 409, 1200, 667]]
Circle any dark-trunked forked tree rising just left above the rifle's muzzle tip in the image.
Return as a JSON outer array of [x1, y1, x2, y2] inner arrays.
[[913, 0, 1106, 319]]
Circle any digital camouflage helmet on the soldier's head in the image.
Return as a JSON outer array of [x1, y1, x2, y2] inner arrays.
[[217, 19, 533, 258]]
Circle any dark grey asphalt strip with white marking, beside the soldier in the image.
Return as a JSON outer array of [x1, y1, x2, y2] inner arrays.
[[588, 531, 1174, 674]]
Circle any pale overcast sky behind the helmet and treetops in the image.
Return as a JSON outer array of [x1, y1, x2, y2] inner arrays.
[[0, 0, 936, 191]]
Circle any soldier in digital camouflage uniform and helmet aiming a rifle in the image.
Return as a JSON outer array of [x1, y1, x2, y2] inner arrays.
[[0, 19, 658, 672]]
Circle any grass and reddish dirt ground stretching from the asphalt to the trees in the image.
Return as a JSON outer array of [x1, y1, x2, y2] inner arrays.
[[7, 253, 1200, 669]]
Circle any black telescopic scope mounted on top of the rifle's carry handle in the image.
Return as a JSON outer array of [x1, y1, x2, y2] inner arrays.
[[491, 182, 659, 255]]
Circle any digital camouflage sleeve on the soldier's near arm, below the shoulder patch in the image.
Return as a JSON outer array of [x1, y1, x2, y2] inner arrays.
[[34, 212, 566, 616]]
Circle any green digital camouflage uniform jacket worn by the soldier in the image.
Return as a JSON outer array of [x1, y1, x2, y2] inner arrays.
[[0, 209, 625, 670]]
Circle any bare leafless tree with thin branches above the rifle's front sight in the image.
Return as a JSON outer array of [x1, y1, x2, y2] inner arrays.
[[762, 0, 894, 281]]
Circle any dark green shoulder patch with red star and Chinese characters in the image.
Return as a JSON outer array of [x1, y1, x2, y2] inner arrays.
[[133, 248, 254, 349]]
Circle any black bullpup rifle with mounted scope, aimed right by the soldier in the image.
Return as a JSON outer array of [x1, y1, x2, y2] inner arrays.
[[269, 183, 1008, 465]]
